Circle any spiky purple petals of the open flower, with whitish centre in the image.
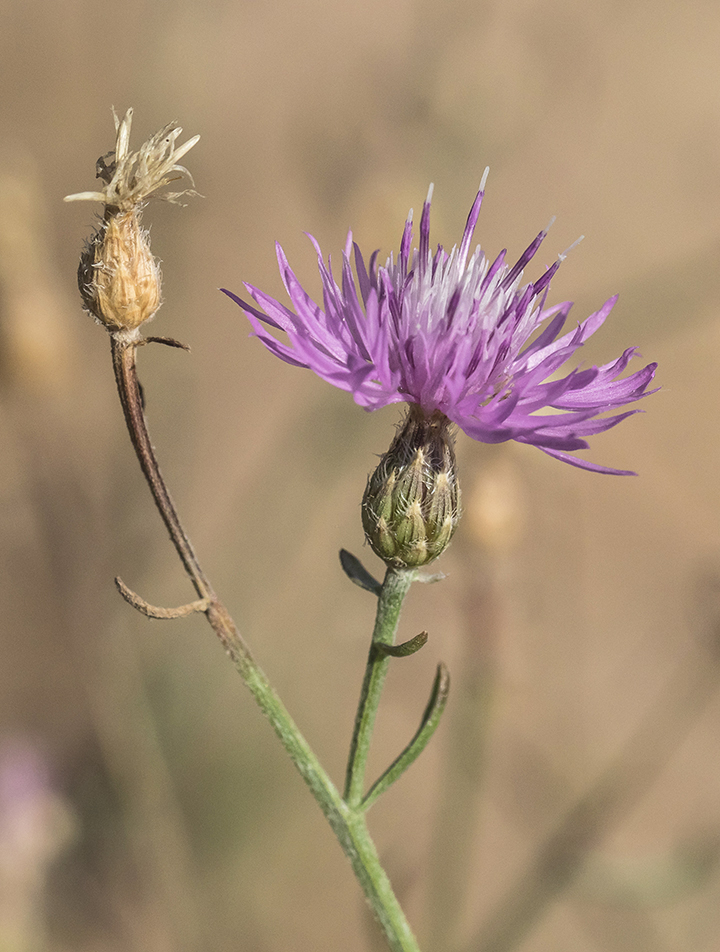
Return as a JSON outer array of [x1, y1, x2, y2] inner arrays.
[[225, 171, 657, 475]]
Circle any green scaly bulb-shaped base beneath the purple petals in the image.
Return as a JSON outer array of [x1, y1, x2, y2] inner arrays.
[[362, 404, 460, 568]]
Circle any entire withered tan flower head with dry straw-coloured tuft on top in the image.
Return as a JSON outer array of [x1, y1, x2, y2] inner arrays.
[[65, 109, 200, 336]]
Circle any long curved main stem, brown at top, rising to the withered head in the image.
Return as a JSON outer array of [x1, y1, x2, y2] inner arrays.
[[107, 335, 420, 952]]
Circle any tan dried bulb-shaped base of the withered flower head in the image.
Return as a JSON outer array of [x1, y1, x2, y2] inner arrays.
[[78, 209, 161, 331]]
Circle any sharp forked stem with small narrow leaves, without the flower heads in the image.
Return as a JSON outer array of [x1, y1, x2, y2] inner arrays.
[[111, 332, 434, 952]]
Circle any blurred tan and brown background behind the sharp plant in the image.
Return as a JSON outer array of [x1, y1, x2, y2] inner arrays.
[[0, 0, 720, 952]]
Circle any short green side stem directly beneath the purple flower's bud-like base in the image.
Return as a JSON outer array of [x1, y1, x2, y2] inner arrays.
[[345, 567, 417, 809]]
